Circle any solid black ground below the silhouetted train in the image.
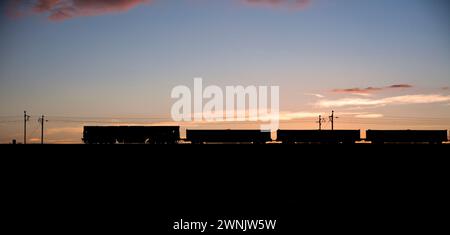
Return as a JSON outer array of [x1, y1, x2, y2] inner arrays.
[[1, 145, 449, 234]]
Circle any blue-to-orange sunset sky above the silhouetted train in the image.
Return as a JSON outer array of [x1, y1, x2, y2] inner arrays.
[[0, 0, 450, 143]]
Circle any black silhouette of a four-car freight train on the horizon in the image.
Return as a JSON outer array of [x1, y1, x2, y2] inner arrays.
[[82, 126, 448, 144]]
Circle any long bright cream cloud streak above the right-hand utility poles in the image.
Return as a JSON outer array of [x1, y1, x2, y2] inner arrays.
[[316, 94, 450, 108]]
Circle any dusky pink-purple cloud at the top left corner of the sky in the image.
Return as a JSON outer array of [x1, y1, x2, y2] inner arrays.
[[10, 0, 152, 21]]
